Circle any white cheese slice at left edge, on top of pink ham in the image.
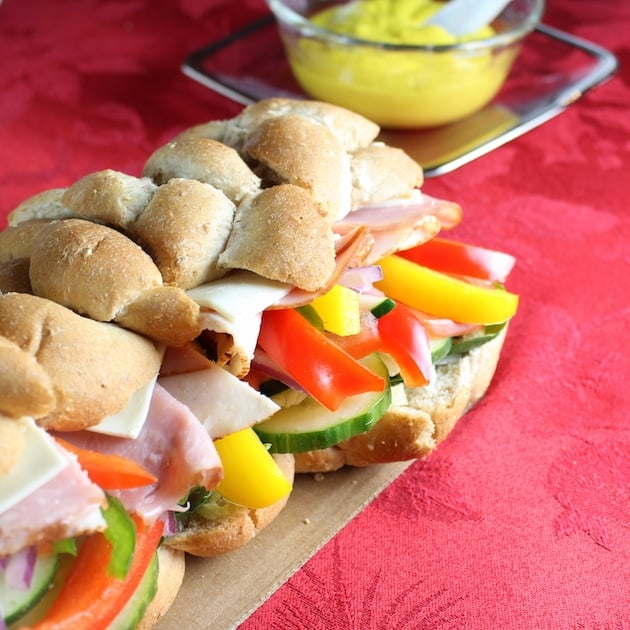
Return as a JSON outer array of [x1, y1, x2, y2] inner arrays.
[[0, 418, 68, 514]]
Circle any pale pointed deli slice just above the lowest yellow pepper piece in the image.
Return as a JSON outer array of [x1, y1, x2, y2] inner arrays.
[[159, 365, 280, 439]]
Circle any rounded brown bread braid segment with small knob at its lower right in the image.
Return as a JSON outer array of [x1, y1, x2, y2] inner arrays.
[[29, 219, 200, 345]]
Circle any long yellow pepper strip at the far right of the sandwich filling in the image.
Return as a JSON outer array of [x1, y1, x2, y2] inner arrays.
[[375, 255, 518, 324]]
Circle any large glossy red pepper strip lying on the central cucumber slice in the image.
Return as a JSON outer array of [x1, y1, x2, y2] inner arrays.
[[258, 309, 385, 411]]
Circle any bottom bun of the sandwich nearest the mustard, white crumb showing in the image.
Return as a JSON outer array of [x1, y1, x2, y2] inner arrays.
[[295, 328, 506, 473]]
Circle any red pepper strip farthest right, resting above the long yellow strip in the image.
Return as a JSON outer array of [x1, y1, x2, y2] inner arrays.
[[398, 238, 516, 282]]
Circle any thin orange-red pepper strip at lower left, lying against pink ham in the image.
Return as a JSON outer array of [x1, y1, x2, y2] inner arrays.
[[55, 437, 157, 490]]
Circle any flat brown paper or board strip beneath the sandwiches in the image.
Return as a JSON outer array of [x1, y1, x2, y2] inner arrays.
[[155, 462, 411, 630]]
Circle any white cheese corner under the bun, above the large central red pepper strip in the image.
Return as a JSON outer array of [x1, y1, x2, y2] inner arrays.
[[186, 270, 293, 321]]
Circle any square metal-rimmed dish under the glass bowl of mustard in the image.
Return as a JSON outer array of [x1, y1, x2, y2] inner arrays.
[[182, 15, 618, 177]]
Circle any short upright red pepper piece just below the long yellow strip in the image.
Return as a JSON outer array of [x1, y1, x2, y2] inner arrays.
[[378, 304, 433, 387]]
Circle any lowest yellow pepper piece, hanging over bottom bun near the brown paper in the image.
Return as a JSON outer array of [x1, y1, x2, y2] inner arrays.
[[214, 428, 293, 508]]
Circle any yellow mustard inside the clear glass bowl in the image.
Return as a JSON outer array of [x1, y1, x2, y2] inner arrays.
[[285, 0, 516, 128]]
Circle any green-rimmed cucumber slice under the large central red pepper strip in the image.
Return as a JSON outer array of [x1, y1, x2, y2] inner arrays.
[[253, 354, 391, 453]]
